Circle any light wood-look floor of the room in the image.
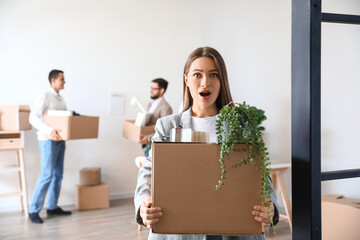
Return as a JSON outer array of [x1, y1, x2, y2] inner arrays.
[[0, 199, 291, 240]]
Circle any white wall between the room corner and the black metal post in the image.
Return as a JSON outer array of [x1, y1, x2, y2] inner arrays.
[[203, 0, 291, 206]]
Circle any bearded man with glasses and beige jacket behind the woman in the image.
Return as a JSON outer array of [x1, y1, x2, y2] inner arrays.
[[140, 78, 172, 157]]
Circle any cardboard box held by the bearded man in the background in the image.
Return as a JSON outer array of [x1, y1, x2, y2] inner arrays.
[[123, 120, 155, 143]]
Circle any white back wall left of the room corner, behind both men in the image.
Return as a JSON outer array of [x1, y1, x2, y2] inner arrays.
[[0, 0, 201, 210]]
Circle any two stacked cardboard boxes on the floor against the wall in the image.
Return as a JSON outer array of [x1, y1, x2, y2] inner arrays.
[[75, 168, 110, 210]]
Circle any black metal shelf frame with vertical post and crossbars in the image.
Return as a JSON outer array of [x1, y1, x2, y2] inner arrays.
[[291, 0, 360, 240]]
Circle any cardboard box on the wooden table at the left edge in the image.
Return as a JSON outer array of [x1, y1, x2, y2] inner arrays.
[[0, 105, 31, 131]]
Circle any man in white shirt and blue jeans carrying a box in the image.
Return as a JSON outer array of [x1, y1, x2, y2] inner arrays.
[[29, 70, 71, 223]]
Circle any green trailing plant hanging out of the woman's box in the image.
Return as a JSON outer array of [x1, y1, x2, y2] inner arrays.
[[216, 102, 273, 231]]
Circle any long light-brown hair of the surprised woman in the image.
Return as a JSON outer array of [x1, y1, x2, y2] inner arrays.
[[183, 47, 232, 111]]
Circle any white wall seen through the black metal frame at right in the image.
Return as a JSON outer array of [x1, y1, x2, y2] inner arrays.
[[321, 0, 360, 198]]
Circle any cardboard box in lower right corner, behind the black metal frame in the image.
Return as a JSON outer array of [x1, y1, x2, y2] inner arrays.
[[321, 195, 360, 240]]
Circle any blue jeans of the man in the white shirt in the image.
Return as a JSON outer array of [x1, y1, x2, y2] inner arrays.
[[29, 140, 65, 213]]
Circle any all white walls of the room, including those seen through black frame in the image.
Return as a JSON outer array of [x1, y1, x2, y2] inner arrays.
[[0, 0, 360, 214]]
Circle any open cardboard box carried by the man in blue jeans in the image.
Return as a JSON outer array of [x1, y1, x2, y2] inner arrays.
[[44, 115, 99, 140]]
